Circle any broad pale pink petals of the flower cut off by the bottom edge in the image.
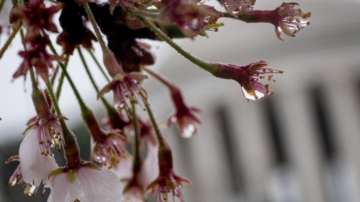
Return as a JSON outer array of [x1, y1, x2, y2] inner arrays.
[[48, 162, 123, 202]]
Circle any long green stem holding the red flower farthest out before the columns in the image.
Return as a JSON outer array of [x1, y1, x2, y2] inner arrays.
[[137, 16, 218, 74]]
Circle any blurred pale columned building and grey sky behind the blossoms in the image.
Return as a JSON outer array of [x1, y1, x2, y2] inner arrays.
[[0, 0, 360, 202]]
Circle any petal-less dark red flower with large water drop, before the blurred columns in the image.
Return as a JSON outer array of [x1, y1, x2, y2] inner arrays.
[[215, 60, 283, 100]]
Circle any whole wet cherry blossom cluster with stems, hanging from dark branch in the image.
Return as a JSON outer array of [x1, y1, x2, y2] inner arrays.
[[0, 0, 310, 202]]
